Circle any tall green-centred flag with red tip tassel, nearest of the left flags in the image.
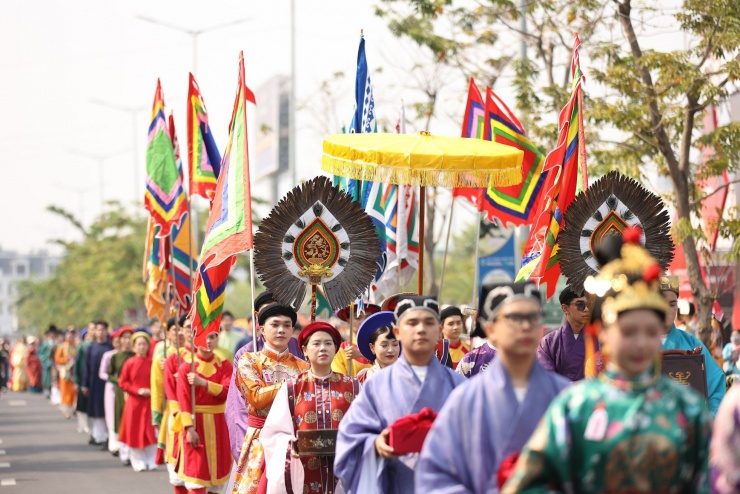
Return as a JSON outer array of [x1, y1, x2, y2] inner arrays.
[[192, 52, 254, 346]]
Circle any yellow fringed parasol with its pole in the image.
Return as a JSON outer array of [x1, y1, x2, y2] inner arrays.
[[321, 132, 524, 294]]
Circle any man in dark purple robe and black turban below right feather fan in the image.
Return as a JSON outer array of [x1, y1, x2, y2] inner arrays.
[[537, 286, 599, 382]]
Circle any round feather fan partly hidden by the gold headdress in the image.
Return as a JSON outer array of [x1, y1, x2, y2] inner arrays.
[[558, 172, 673, 293]]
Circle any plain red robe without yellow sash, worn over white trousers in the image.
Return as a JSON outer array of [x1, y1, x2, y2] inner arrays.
[[118, 355, 157, 449]]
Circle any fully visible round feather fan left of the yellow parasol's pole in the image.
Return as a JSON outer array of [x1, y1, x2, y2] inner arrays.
[[254, 177, 380, 319]]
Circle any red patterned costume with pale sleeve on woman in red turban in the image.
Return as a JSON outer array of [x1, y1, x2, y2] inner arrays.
[[260, 370, 359, 494]]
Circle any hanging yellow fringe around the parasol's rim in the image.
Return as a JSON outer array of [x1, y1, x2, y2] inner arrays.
[[321, 154, 522, 188]]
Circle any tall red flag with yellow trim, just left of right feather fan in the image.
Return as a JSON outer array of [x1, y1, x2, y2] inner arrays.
[[517, 34, 588, 298]]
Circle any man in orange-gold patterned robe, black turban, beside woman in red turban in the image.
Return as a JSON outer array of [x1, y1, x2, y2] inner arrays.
[[231, 303, 309, 494]]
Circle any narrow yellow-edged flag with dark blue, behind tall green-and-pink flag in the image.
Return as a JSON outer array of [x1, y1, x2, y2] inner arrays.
[[188, 74, 221, 199]]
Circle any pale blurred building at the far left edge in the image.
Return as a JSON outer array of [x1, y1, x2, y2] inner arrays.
[[0, 250, 61, 335]]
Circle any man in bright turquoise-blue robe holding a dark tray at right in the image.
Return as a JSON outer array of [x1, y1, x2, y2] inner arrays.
[[660, 276, 726, 416]]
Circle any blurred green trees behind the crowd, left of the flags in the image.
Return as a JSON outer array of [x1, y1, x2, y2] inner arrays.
[[17, 203, 146, 330]]
